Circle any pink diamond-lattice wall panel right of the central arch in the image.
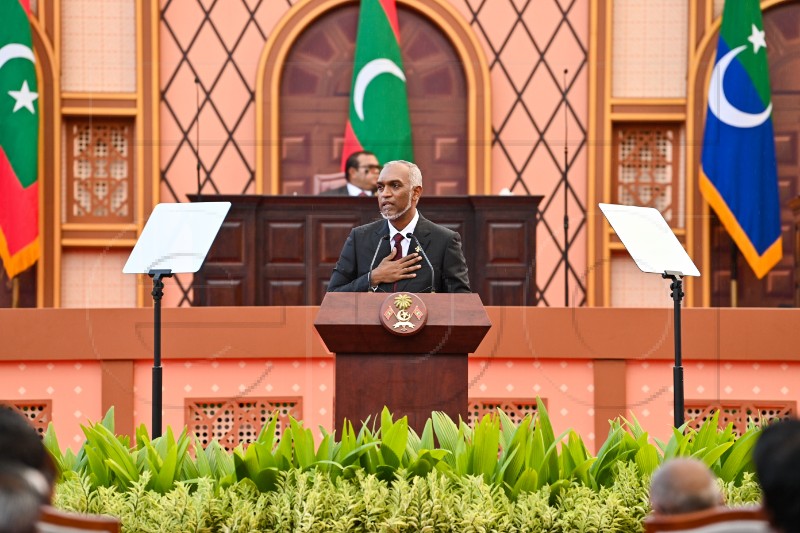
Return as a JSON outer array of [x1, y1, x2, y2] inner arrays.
[[454, 0, 589, 306]]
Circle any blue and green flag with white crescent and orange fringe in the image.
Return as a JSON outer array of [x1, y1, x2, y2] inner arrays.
[[700, 0, 783, 278]]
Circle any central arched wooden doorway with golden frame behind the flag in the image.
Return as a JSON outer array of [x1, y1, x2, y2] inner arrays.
[[256, 0, 491, 194]]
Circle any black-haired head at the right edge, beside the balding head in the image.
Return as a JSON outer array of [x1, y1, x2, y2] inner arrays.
[[753, 420, 800, 533]]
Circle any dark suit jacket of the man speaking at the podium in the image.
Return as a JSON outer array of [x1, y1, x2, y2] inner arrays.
[[328, 215, 471, 292]]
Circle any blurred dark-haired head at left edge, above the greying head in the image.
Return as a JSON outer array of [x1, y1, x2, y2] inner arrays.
[[0, 404, 57, 502]]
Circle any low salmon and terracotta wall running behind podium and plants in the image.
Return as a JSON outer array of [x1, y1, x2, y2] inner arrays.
[[0, 307, 800, 447]]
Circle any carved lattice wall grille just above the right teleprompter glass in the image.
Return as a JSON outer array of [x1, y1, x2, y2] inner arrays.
[[612, 124, 683, 228]]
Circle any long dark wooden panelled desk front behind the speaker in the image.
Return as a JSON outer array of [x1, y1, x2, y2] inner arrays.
[[192, 195, 541, 305]]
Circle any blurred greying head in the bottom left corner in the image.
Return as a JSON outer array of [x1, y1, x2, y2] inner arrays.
[[0, 460, 45, 533]]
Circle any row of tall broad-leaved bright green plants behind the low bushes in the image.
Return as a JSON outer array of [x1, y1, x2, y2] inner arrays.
[[44, 400, 759, 504]]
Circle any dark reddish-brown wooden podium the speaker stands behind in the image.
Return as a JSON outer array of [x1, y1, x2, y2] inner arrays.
[[314, 292, 491, 434]]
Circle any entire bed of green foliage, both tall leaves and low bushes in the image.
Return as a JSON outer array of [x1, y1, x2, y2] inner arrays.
[[44, 401, 760, 532]]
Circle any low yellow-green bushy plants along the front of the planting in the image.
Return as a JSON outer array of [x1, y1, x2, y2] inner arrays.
[[55, 462, 758, 532]]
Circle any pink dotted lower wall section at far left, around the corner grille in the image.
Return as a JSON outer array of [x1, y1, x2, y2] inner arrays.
[[0, 360, 105, 451]]
